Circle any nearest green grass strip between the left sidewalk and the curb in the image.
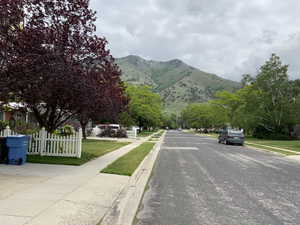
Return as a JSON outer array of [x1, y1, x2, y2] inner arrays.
[[101, 142, 155, 176]]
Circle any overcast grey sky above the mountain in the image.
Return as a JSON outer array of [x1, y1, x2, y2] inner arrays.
[[91, 0, 300, 80]]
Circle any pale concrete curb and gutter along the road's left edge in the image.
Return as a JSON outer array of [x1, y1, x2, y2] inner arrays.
[[99, 132, 166, 225]]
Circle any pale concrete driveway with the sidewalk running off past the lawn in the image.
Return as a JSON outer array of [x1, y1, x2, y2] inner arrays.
[[0, 139, 147, 225]]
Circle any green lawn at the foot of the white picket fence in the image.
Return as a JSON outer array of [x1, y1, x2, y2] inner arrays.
[[27, 140, 130, 166]]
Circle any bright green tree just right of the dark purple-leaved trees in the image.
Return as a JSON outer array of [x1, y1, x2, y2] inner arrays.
[[126, 85, 162, 129]]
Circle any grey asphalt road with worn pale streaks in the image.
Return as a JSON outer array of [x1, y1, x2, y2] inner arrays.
[[136, 131, 300, 225]]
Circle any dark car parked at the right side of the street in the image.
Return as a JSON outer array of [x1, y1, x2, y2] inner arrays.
[[218, 129, 245, 145]]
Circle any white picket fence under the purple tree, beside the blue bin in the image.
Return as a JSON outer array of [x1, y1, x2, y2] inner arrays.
[[0, 127, 82, 158]]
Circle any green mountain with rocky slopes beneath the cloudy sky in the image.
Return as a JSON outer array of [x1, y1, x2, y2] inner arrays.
[[116, 55, 240, 112]]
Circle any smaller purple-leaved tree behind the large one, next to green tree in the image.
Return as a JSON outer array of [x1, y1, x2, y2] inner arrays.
[[74, 54, 128, 138]]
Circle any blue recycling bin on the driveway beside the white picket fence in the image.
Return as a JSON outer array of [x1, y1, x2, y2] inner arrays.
[[6, 135, 29, 165]]
